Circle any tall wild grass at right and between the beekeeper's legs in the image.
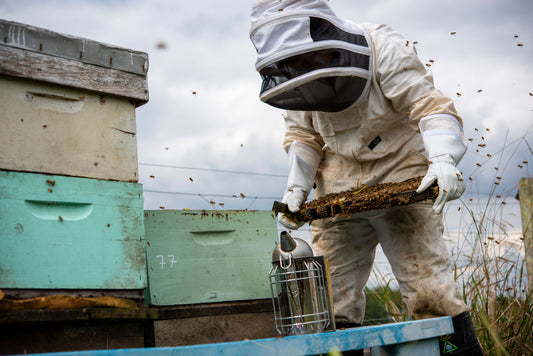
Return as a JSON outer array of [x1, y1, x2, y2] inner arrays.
[[367, 130, 533, 356]]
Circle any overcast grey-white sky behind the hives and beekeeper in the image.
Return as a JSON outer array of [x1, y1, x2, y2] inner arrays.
[[0, 0, 533, 248]]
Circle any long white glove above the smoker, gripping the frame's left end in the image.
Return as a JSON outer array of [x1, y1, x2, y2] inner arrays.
[[278, 141, 320, 230]]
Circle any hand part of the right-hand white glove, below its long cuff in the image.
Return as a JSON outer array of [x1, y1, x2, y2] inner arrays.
[[416, 154, 466, 214]]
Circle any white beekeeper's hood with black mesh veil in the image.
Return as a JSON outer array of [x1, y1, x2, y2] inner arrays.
[[250, 0, 372, 112]]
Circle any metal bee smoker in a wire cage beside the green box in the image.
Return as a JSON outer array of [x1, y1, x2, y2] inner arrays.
[[270, 231, 335, 336]]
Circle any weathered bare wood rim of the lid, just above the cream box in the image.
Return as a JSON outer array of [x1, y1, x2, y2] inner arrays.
[[0, 45, 148, 106]]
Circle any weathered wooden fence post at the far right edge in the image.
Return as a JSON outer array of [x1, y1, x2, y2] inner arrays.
[[518, 178, 533, 295]]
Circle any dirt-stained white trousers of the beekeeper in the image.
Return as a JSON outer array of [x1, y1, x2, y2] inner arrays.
[[312, 202, 467, 324]]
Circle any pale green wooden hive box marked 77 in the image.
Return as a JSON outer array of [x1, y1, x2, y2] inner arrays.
[[144, 210, 278, 305]]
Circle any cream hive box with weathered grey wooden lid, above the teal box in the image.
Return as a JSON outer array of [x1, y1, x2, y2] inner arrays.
[[0, 20, 148, 182]]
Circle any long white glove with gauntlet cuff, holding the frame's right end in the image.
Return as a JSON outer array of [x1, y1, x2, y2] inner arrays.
[[416, 114, 466, 214]]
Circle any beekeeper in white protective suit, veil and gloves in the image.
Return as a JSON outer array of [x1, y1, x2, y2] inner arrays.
[[250, 0, 481, 355]]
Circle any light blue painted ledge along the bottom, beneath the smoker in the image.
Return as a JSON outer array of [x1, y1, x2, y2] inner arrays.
[[19, 317, 453, 356]]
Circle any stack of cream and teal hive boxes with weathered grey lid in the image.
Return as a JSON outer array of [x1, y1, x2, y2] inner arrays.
[[0, 20, 148, 295]]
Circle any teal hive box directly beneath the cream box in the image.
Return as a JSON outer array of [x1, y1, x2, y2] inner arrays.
[[0, 170, 147, 290]]
